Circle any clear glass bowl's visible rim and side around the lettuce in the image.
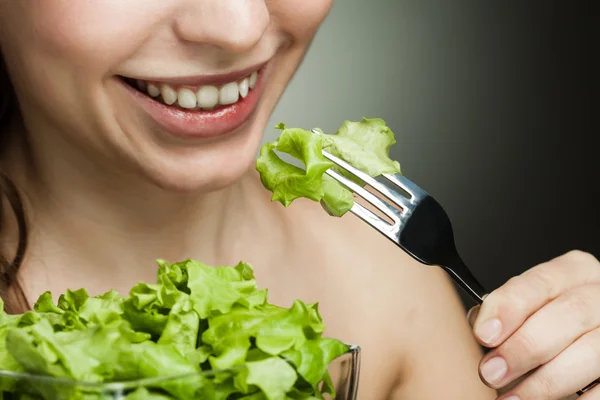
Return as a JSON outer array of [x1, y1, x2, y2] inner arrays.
[[0, 346, 360, 400]]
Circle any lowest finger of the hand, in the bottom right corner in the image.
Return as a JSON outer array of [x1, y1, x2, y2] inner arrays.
[[501, 329, 600, 400]]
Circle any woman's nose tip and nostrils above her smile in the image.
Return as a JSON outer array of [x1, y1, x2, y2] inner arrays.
[[175, 0, 270, 52]]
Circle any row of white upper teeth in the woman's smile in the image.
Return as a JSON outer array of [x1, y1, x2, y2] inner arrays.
[[137, 72, 258, 110]]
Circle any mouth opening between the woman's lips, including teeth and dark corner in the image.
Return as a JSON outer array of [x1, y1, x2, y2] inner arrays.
[[121, 71, 259, 111]]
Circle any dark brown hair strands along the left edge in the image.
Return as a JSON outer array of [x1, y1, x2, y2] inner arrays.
[[0, 54, 28, 313]]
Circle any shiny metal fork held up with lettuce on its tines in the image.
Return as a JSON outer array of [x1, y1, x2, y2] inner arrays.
[[323, 145, 600, 395]]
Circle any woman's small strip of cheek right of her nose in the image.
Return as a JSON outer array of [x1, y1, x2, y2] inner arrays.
[[267, 0, 333, 40]]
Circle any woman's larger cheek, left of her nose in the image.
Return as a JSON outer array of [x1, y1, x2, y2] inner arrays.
[[3, 0, 168, 69]]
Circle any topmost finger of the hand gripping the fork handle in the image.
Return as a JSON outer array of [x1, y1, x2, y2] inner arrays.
[[474, 251, 600, 347]]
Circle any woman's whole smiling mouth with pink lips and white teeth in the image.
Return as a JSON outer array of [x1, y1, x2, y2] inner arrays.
[[117, 63, 269, 140]]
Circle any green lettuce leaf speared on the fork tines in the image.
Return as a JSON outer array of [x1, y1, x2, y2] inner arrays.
[[256, 118, 401, 217]]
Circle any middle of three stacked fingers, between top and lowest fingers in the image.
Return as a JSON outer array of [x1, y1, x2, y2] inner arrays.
[[480, 284, 600, 390]]
